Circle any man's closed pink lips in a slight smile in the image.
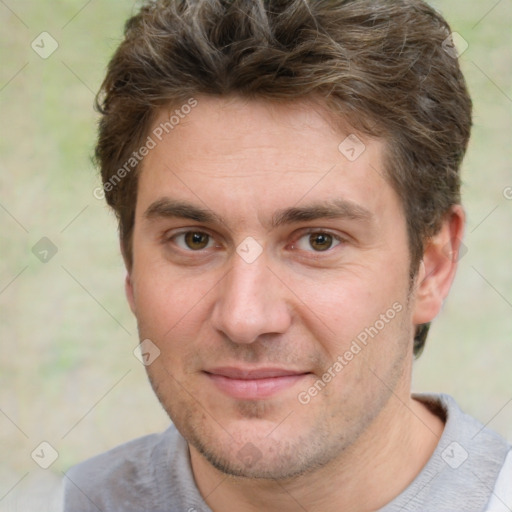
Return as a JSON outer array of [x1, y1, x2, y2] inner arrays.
[[204, 367, 311, 400]]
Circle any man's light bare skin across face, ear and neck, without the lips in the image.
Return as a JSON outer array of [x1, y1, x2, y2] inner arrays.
[[126, 96, 464, 512]]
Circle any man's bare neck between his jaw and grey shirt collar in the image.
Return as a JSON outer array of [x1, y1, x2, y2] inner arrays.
[[189, 392, 444, 512]]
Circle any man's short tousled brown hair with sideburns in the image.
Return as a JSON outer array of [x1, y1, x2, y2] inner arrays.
[[96, 0, 471, 354]]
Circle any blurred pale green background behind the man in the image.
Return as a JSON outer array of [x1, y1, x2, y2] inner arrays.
[[0, 0, 512, 504]]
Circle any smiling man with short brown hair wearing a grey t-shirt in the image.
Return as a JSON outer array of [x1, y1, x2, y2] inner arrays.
[[65, 0, 512, 512]]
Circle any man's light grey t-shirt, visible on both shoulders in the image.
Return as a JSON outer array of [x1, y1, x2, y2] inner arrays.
[[64, 395, 511, 512]]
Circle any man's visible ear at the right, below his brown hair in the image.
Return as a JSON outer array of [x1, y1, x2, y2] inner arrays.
[[413, 205, 466, 325]]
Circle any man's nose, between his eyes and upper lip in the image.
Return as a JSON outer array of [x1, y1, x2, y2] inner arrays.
[[212, 249, 292, 344]]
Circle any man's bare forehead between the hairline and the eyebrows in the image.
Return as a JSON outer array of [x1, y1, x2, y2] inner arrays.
[[137, 96, 397, 226]]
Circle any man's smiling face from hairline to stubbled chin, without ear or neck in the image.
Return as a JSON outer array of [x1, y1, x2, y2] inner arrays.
[[127, 96, 413, 478]]
